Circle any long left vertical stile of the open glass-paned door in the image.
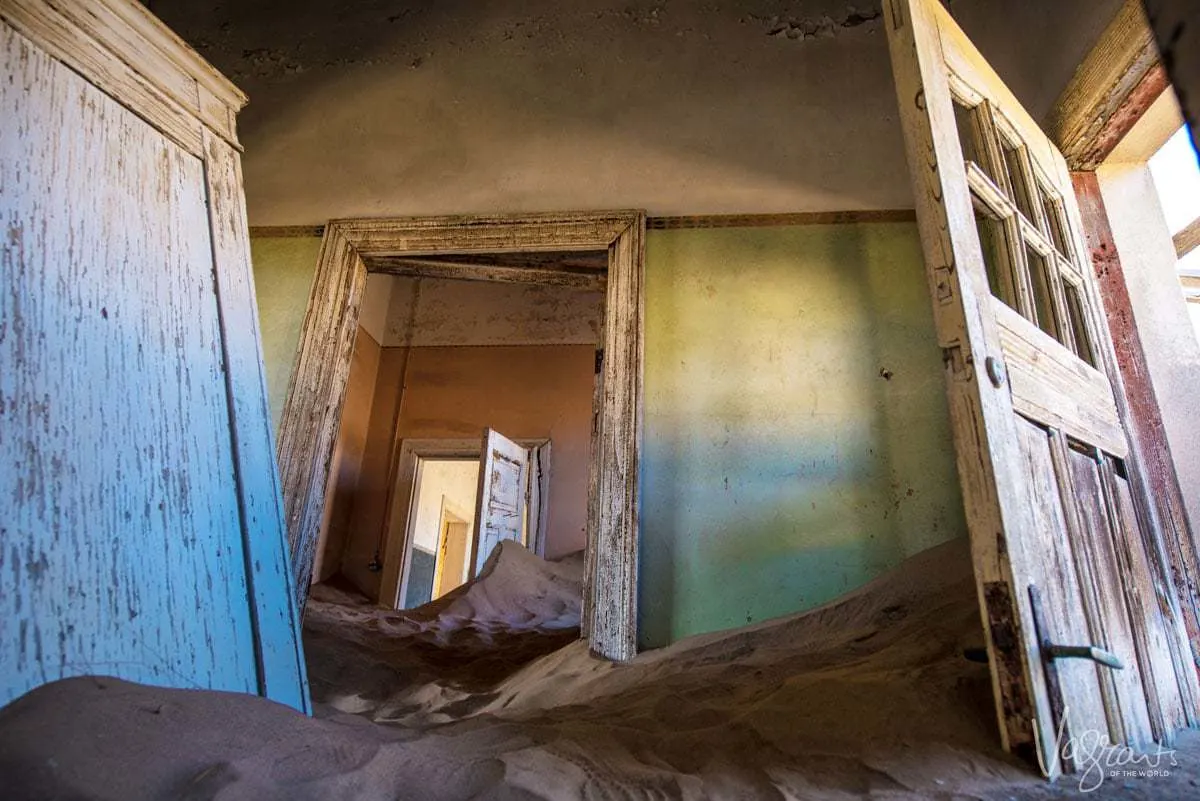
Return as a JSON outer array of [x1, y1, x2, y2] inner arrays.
[[884, 0, 1054, 763]]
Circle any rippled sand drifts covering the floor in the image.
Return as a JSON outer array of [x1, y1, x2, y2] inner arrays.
[[0, 541, 1200, 801]]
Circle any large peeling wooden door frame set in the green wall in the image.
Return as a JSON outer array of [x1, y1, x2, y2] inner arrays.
[[277, 211, 646, 660]]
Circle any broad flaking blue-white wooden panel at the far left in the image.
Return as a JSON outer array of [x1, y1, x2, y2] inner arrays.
[[0, 23, 258, 703]]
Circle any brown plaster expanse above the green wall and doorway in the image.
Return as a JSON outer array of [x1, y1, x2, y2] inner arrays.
[[151, 0, 1120, 225]]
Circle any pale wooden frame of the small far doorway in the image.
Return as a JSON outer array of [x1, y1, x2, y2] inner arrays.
[[379, 436, 552, 609]]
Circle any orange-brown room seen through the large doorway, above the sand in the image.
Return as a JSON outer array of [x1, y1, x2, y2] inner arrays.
[[314, 253, 605, 609]]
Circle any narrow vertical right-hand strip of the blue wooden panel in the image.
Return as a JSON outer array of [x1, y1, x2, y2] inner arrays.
[[204, 133, 310, 712]]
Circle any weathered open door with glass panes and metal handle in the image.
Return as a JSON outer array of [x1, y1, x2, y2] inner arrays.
[[883, 0, 1198, 775]]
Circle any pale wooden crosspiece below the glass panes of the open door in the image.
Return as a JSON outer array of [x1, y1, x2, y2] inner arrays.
[[991, 299, 1128, 457]]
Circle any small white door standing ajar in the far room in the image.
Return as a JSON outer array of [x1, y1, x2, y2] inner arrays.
[[472, 428, 529, 576]]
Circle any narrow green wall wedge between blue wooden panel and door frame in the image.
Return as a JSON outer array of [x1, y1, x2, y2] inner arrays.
[[250, 236, 320, 430]]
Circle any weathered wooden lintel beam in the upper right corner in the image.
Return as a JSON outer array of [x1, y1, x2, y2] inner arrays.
[[1049, 0, 1168, 170]]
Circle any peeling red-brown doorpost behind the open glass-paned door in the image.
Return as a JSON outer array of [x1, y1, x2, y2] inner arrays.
[[1072, 173, 1200, 695]]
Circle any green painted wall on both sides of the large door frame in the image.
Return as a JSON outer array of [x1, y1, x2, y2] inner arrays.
[[252, 223, 966, 648]]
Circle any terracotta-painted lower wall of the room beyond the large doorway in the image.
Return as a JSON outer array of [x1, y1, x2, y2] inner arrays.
[[320, 340, 595, 597]]
